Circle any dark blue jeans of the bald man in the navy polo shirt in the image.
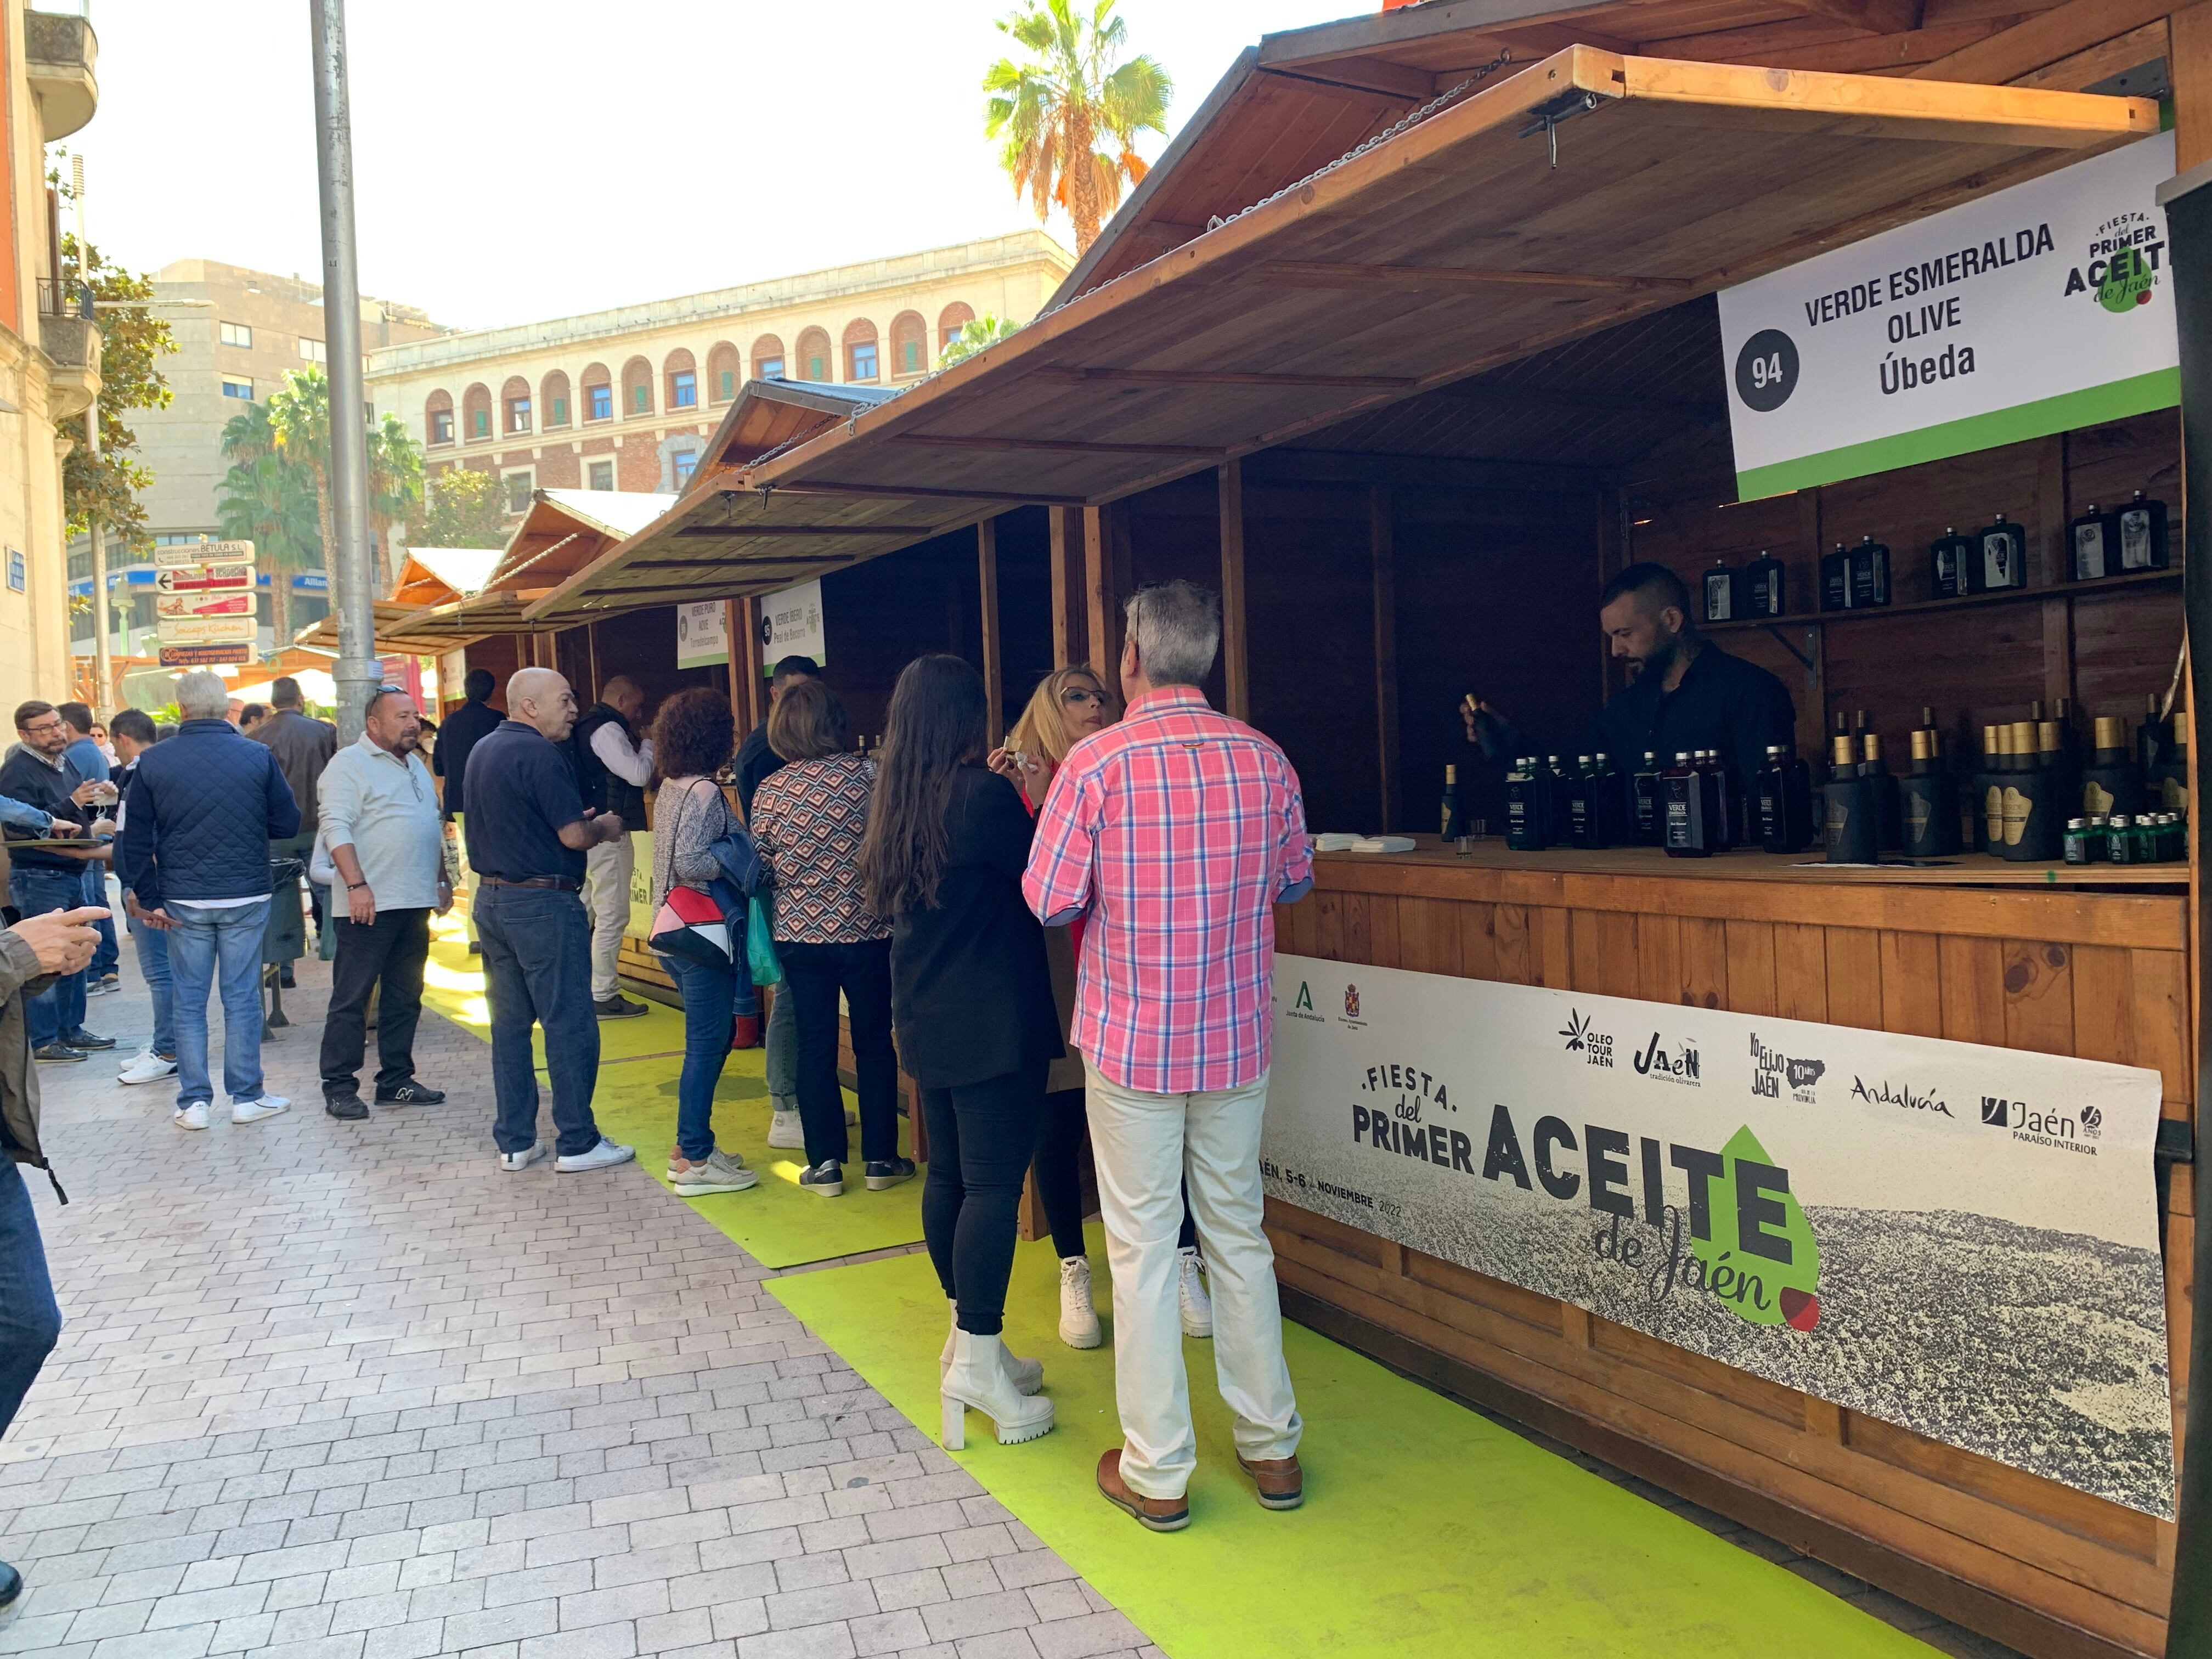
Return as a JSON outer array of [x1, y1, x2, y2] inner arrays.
[[471, 881, 601, 1157]]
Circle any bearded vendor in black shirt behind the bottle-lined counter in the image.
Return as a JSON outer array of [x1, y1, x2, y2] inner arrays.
[[1460, 564, 1796, 787]]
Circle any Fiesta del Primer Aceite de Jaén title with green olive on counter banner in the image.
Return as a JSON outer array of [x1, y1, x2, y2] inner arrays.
[[1336, 1066, 1820, 1331]]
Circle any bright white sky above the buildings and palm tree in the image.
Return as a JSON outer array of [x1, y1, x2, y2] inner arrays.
[[66, 0, 1345, 328]]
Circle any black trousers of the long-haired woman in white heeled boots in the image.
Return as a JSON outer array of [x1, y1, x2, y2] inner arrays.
[[922, 1066, 1044, 1336]]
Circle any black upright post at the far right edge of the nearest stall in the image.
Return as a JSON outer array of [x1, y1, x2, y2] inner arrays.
[[2159, 161, 2212, 1655]]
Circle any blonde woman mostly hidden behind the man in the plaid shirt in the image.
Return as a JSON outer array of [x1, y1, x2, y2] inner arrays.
[[989, 666, 1215, 1347]]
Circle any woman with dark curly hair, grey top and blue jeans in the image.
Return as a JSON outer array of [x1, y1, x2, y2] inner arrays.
[[652, 686, 761, 1199]]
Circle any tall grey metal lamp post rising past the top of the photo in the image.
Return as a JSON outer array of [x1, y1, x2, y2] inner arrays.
[[309, 0, 383, 743]]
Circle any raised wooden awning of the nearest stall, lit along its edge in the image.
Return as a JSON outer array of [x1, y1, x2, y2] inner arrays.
[[529, 47, 2159, 626]]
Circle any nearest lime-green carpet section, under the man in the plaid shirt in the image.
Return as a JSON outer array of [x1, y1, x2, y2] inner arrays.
[[770, 1241, 1929, 1659]]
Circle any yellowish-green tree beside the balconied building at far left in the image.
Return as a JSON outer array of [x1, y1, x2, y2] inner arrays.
[[53, 236, 177, 553]]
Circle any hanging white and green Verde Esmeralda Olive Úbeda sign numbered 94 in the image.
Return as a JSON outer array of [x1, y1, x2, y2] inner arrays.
[[1721, 133, 2181, 500]]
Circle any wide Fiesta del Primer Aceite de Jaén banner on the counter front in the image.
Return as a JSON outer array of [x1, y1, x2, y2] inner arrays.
[[1261, 956, 2174, 1517]]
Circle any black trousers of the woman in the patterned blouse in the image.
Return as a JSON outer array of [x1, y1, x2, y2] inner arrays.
[[776, 938, 898, 1166]]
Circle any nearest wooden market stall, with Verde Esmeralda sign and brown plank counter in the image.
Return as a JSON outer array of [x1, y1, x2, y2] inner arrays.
[[506, 16, 2212, 1655]]
